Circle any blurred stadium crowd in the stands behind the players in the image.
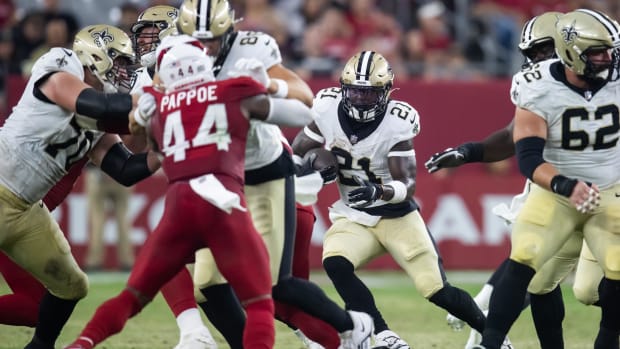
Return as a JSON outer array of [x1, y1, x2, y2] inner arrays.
[[0, 0, 620, 85]]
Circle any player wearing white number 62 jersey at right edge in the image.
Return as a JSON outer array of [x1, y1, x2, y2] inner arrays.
[[480, 10, 620, 349]]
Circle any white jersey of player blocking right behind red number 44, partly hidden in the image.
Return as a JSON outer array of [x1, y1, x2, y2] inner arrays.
[[216, 31, 284, 170]]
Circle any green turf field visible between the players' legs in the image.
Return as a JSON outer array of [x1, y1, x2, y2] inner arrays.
[[0, 272, 599, 349]]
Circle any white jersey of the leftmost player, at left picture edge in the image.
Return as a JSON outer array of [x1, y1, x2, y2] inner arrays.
[[0, 48, 103, 203]]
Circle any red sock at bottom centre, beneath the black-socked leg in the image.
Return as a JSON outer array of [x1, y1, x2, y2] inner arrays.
[[276, 302, 340, 349]]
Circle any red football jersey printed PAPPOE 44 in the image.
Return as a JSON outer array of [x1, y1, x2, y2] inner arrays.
[[145, 77, 267, 183]]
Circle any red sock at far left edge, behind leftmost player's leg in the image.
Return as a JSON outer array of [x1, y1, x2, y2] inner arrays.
[[0, 294, 40, 327]]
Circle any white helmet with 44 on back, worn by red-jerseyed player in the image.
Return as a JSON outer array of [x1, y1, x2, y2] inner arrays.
[[157, 40, 215, 92]]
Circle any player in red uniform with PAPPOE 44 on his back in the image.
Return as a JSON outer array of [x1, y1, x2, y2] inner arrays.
[[68, 36, 330, 349]]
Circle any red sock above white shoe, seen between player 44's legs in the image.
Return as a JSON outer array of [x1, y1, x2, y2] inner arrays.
[[161, 268, 198, 317]]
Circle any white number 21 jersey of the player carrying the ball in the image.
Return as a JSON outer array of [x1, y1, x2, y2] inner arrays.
[[312, 87, 420, 207]]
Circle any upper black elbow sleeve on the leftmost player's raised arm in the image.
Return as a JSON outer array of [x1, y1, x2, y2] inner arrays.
[[75, 88, 133, 134]]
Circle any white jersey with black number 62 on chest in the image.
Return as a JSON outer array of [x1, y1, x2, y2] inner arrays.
[[510, 60, 620, 189]]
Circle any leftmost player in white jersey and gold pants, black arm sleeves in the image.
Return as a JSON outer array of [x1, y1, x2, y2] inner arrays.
[[0, 25, 151, 349]]
